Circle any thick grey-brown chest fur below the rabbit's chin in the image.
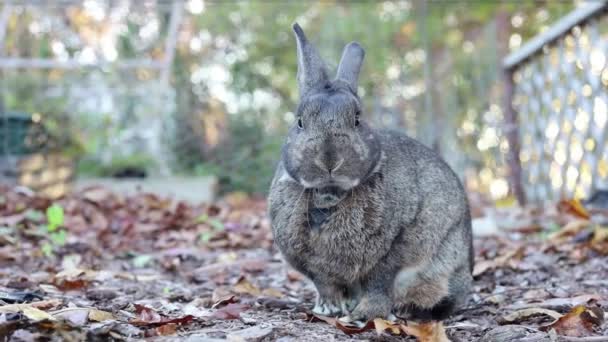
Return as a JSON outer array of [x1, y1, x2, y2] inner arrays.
[[271, 173, 390, 283]]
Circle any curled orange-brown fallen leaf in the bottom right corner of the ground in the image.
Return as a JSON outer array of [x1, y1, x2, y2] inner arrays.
[[541, 305, 604, 337]]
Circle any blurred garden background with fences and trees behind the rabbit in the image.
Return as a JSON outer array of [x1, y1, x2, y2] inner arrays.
[[0, 0, 608, 206]]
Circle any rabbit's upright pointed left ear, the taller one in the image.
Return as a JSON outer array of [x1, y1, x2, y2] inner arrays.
[[293, 23, 328, 97]]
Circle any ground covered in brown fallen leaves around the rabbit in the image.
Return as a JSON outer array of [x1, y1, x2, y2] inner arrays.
[[0, 188, 608, 342]]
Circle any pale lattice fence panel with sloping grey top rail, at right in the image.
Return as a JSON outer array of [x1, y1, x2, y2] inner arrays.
[[504, 1, 608, 203]]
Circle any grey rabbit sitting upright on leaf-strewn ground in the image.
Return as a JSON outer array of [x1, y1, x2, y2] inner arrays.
[[269, 23, 473, 322]]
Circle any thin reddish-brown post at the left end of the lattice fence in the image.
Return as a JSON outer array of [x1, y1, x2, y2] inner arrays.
[[496, 11, 526, 205]]
